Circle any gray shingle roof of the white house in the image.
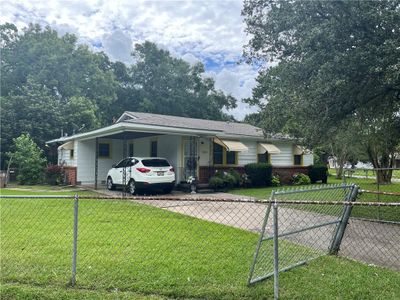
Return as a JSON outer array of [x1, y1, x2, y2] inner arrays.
[[119, 111, 264, 138]]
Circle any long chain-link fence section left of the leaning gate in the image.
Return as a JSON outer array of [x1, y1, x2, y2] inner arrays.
[[0, 196, 267, 296]]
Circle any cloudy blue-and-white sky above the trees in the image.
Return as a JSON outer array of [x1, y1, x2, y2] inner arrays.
[[0, 0, 257, 120]]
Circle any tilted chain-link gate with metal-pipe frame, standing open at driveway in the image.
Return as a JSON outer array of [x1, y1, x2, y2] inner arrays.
[[248, 184, 358, 298]]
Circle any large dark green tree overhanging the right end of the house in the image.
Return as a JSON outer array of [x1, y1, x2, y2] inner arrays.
[[242, 0, 400, 181]]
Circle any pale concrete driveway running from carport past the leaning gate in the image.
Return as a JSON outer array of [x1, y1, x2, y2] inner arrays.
[[97, 192, 400, 271]]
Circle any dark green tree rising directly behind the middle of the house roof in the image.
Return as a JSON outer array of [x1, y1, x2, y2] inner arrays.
[[126, 42, 236, 120]]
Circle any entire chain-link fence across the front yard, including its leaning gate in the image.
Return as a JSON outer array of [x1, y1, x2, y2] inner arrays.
[[0, 185, 400, 298]]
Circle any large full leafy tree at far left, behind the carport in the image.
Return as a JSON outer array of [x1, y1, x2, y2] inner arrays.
[[0, 23, 117, 164]]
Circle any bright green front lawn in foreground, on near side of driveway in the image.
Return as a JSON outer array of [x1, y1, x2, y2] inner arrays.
[[0, 186, 400, 299]]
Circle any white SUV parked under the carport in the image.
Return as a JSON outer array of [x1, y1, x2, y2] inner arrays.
[[107, 157, 175, 195]]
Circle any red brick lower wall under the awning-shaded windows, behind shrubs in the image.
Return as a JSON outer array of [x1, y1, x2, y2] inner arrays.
[[199, 166, 308, 184]]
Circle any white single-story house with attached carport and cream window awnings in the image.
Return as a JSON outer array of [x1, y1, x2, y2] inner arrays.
[[47, 112, 313, 187]]
